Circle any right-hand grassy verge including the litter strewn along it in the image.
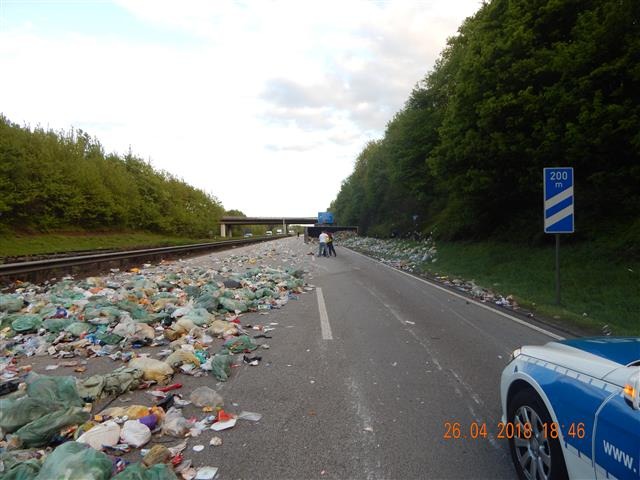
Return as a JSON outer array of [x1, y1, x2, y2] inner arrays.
[[348, 235, 640, 335]]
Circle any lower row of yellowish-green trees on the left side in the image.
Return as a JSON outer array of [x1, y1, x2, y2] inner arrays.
[[0, 116, 224, 237]]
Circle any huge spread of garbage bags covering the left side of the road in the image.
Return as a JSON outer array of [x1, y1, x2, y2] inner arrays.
[[0, 248, 313, 480]]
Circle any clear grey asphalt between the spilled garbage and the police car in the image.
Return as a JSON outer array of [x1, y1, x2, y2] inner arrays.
[[206, 239, 564, 479]]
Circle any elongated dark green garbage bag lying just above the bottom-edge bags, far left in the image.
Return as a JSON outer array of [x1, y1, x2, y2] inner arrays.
[[15, 407, 91, 448]]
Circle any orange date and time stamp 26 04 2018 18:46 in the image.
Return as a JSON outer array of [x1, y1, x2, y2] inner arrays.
[[442, 422, 585, 440]]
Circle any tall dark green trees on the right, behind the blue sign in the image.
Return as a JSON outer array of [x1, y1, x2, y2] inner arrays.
[[331, 0, 640, 253]]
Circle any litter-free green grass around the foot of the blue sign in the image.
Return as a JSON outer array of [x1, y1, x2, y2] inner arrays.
[[423, 243, 640, 335]]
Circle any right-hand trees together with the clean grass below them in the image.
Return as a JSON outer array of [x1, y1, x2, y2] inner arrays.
[[330, 0, 640, 335]]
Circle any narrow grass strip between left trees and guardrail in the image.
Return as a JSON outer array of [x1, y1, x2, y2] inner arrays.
[[0, 232, 218, 258]]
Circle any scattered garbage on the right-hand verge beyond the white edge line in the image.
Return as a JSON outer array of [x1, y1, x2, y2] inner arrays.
[[337, 232, 519, 310]]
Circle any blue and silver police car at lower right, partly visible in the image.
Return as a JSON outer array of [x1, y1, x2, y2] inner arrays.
[[500, 337, 640, 480]]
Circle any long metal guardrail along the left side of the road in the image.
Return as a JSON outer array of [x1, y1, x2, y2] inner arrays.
[[0, 236, 284, 282]]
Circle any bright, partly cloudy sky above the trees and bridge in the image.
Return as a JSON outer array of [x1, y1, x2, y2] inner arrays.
[[0, 0, 481, 221]]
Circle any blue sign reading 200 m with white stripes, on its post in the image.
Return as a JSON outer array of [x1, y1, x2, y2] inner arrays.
[[544, 167, 574, 305]]
